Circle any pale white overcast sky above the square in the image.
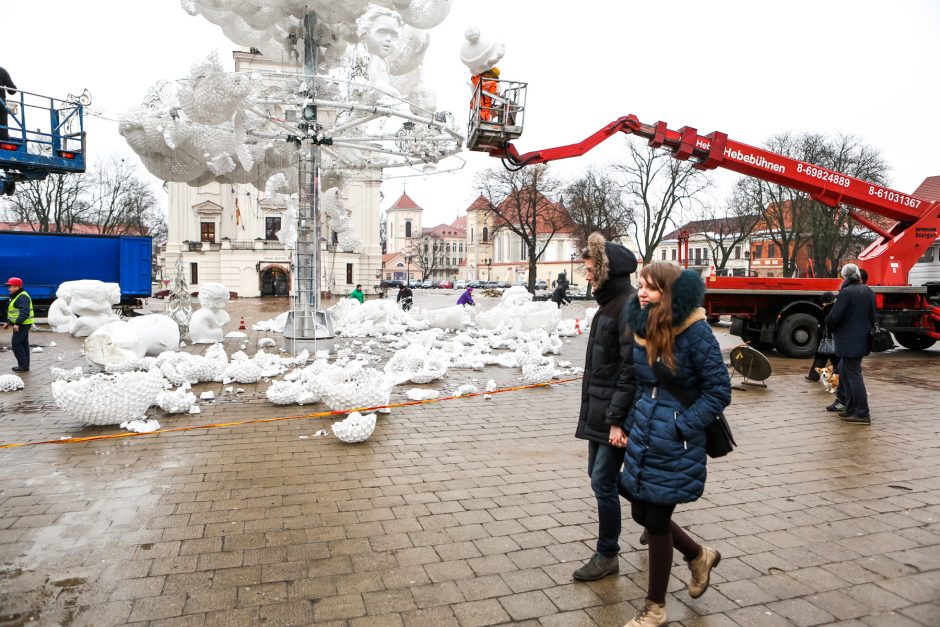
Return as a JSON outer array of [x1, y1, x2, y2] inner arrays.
[[0, 0, 940, 226]]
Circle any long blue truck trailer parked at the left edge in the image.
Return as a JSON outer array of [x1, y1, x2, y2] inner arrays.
[[0, 231, 153, 319]]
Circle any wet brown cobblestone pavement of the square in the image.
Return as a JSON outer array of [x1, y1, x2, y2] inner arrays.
[[0, 296, 940, 627]]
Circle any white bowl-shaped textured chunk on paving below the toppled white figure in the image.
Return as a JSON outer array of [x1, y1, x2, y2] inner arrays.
[[52, 369, 163, 425]]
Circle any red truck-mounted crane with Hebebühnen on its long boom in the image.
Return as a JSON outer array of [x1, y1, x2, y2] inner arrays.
[[468, 81, 940, 358]]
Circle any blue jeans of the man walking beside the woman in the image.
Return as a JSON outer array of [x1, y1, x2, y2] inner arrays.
[[588, 441, 626, 557]]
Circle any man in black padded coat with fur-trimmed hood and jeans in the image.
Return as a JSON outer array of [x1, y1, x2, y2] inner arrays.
[[574, 233, 636, 581]]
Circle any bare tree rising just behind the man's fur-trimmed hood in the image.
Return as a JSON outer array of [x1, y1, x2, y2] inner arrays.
[[563, 168, 634, 248]]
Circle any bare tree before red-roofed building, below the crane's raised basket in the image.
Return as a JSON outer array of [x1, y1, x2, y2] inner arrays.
[[477, 164, 571, 293]]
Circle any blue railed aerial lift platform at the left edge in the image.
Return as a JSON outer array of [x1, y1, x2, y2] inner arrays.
[[0, 91, 85, 196]]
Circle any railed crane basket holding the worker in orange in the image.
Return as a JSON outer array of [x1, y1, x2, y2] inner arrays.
[[467, 79, 527, 152]]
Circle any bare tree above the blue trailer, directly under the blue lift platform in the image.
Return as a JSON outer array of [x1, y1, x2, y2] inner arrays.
[[2, 174, 89, 233]]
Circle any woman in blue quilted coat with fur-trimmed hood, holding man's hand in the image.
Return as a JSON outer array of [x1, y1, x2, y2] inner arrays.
[[621, 262, 731, 627]]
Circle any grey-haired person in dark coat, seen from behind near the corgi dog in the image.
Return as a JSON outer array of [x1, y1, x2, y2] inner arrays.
[[826, 263, 876, 425]]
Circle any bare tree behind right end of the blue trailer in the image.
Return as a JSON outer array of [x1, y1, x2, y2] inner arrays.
[[89, 157, 158, 235]]
